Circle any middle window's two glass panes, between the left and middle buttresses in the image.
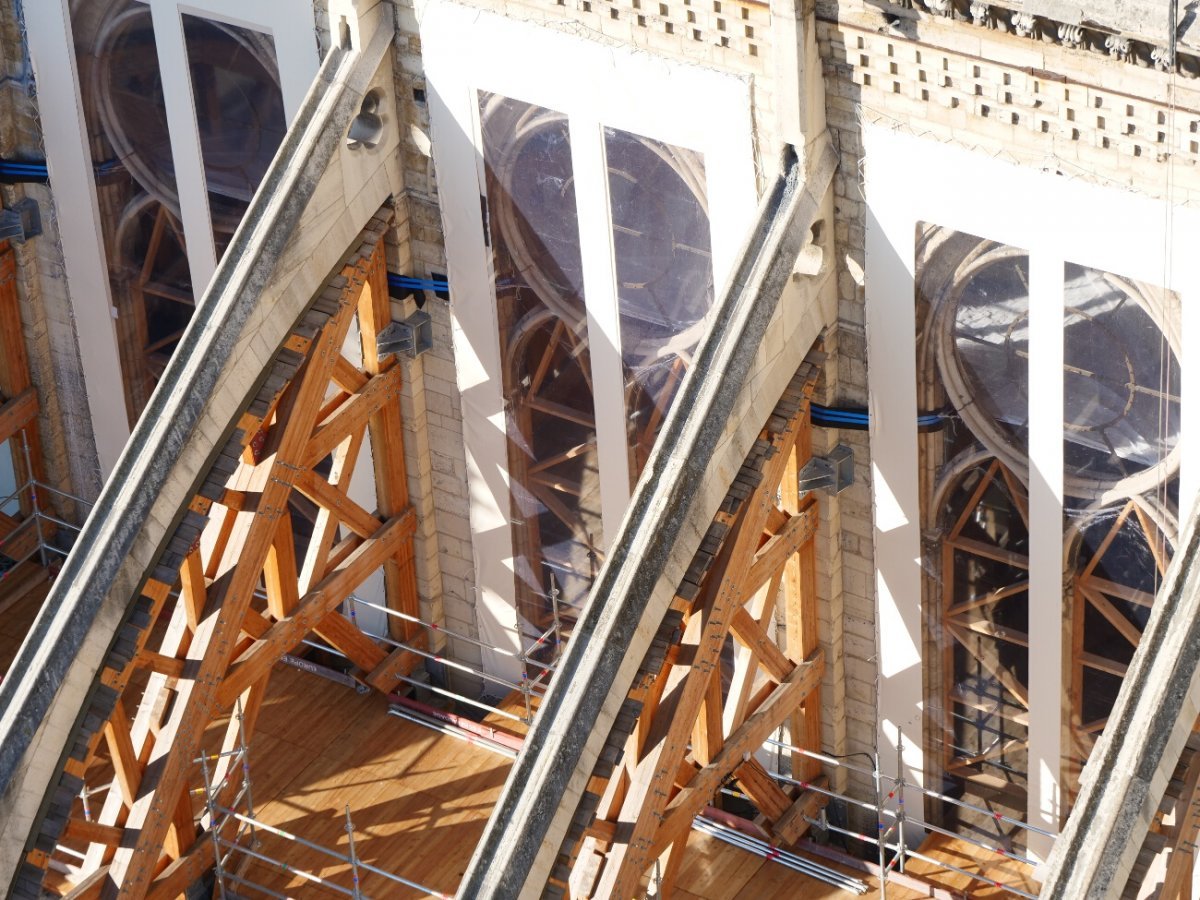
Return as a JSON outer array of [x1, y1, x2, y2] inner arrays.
[[479, 91, 713, 628]]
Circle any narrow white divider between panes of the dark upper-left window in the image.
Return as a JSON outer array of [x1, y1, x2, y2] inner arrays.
[[150, 0, 217, 292]]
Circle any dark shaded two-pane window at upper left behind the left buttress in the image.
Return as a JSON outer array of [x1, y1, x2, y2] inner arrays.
[[71, 0, 296, 424]]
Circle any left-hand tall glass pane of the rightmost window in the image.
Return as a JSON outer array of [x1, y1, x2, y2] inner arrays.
[[913, 224, 1032, 844]]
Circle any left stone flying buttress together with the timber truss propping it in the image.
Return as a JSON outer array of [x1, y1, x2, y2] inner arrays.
[[0, 21, 422, 898]]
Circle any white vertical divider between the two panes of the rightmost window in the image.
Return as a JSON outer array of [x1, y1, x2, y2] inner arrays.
[[1027, 250, 1068, 860]]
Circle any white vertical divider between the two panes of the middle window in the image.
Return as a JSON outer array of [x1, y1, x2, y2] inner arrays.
[[570, 115, 630, 546]]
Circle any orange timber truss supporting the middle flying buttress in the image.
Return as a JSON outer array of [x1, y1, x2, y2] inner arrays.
[[550, 361, 823, 898]]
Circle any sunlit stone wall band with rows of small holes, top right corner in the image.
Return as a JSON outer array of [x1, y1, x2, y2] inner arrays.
[[817, 0, 1200, 205]]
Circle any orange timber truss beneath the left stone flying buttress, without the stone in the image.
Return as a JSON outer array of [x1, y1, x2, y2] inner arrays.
[[21, 217, 424, 898]]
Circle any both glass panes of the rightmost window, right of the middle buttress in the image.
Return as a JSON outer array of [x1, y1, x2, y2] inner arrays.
[[917, 224, 1180, 836]]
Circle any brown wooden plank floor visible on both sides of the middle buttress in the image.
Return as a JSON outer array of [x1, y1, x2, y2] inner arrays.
[[220, 667, 998, 900]]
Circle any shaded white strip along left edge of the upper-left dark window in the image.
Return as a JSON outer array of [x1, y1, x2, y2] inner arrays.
[[25, 0, 130, 476]]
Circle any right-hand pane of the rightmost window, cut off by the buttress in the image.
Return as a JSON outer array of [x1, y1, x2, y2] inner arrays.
[[1063, 263, 1180, 799]]
